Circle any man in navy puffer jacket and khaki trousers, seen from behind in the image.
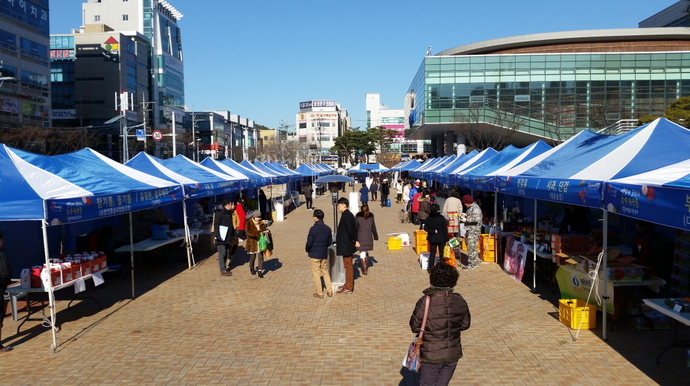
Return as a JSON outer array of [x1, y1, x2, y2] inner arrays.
[[304, 209, 333, 299]]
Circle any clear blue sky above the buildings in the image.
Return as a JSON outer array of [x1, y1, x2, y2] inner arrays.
[[50, 0, 676, 128]]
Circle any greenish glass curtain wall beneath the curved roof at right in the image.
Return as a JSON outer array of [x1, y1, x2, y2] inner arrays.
[[410, 52, 690, 139]]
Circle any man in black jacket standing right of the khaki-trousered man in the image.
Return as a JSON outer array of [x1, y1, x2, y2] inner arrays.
[[335, 197, 359, 294]]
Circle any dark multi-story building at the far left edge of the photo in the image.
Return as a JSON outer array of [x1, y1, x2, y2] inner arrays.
[[0, 0, 51, 129]]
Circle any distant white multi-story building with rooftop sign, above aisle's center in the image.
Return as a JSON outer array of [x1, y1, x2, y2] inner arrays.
[[295, 100, 350, 164]]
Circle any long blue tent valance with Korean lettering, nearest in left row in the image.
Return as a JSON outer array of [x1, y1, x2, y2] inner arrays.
[[48, 186, 182, 225]]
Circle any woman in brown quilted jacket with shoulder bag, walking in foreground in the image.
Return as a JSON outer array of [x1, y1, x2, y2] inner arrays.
[[410, 264, 471, 386]]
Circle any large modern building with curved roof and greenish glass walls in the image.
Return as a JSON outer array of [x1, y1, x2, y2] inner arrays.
[[405, 27, 690, 156]]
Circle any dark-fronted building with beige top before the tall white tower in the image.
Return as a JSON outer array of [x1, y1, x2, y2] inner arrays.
[[50, 24, 153, 160]]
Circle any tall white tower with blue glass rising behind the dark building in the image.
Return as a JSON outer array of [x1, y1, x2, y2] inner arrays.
[[82, 0, 185, 134]]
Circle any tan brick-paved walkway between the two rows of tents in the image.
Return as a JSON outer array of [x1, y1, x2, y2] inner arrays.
[[0, 195, 690, 386]]
